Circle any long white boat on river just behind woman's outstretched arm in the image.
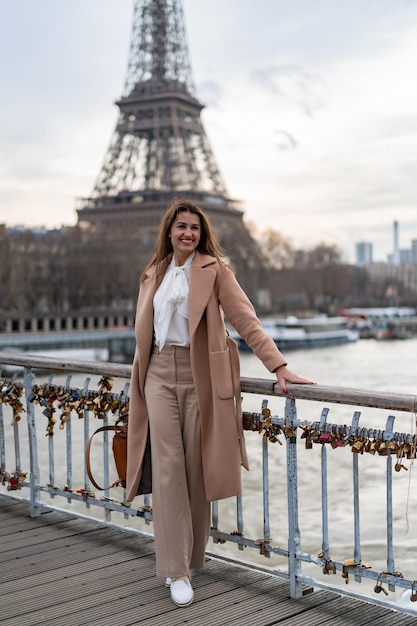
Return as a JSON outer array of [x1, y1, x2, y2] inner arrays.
[[230, 315, 359, 351]]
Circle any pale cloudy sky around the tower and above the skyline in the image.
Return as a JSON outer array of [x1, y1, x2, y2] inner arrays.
[[0, 0, 417, 262]]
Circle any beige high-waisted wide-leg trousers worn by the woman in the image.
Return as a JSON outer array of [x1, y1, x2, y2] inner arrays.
[[145, 346, 210, 578]]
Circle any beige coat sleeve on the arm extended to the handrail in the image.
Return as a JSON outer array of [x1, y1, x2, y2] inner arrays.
[[217, 266, 286, 372]]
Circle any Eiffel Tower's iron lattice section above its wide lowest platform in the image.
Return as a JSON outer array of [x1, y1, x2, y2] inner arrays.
[[94, 0, 226, 196]]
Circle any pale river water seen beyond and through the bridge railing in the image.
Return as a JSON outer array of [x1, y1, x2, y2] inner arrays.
[[20, 337, 417, 599]]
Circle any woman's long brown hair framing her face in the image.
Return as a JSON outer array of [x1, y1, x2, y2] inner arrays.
[[141, 198, 224, 282]]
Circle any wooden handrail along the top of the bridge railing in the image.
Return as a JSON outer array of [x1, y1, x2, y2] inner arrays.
[[0, 351, 417, 413]]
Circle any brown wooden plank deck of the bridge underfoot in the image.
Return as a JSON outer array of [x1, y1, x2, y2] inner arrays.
[[0, 496, 417, 626]]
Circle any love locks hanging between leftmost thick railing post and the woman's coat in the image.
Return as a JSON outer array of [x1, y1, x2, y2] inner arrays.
[[28, 376, 129, 437]]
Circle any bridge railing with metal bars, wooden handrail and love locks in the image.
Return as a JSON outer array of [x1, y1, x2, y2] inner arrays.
[[0, 352, 417, 611]]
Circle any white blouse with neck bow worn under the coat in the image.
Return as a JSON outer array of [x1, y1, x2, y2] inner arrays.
[[153, 254, 194, 350]]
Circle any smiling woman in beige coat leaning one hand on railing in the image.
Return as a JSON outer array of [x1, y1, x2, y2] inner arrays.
[[127, 199, 311, 606]]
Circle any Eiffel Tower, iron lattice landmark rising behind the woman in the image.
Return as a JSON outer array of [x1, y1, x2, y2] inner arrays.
[[77, 0, 260, 286]]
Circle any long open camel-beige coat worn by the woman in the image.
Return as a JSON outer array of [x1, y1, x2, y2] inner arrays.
[[126, 252, 285, 502]]
